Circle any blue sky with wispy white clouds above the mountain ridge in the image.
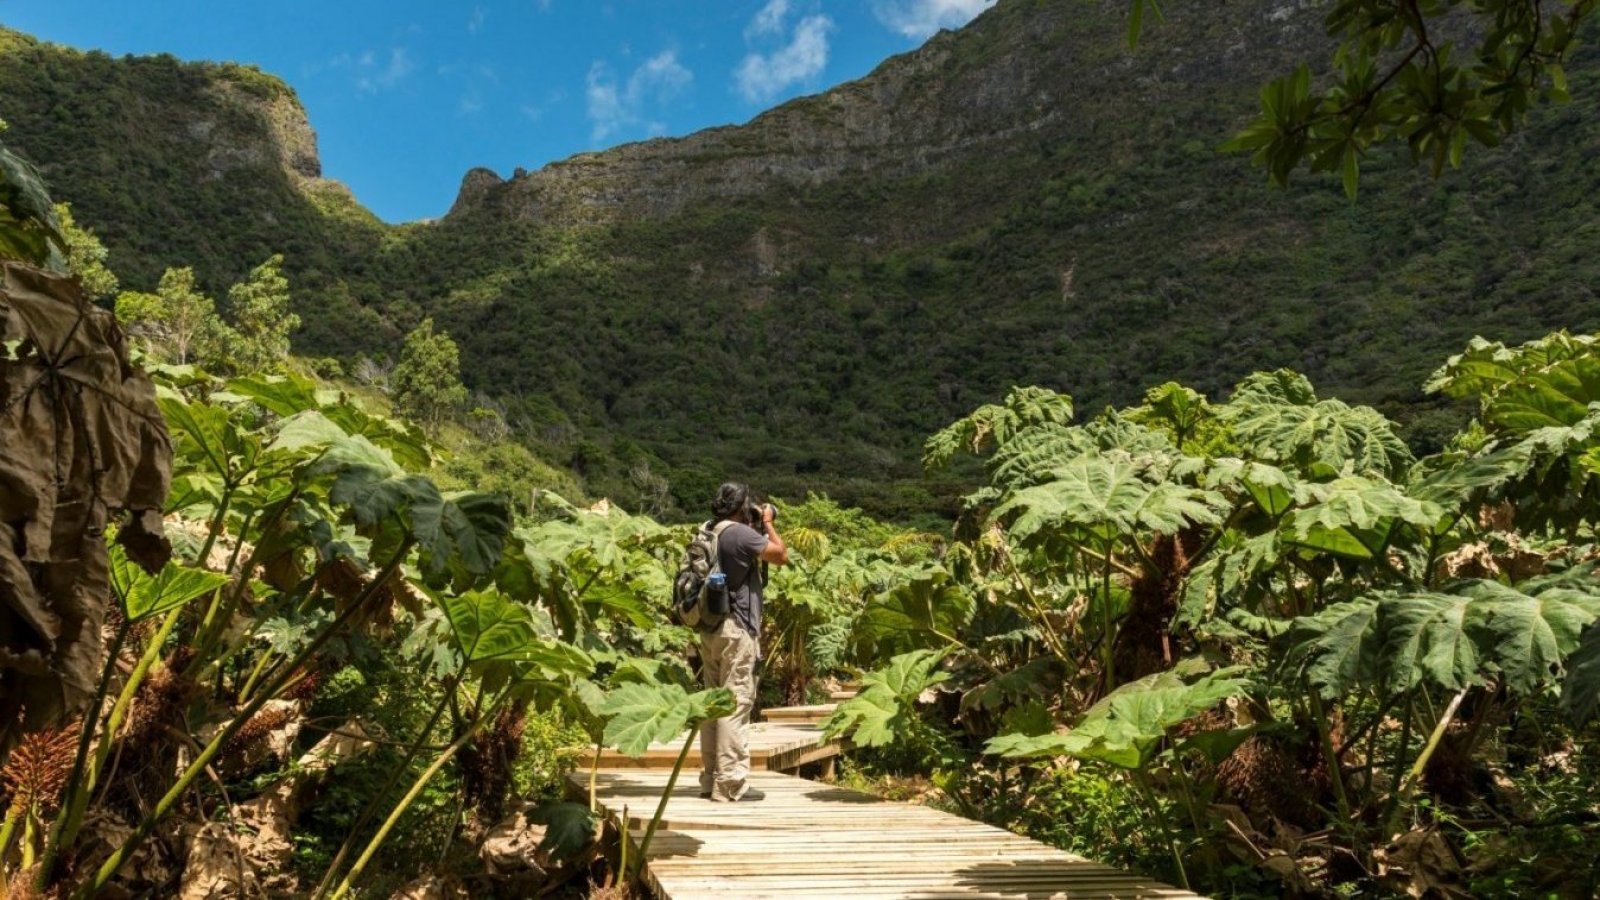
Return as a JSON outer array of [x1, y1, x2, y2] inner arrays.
[[0, 0, 994, 221]]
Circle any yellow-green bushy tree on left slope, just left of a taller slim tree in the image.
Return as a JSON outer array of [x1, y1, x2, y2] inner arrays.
[[117, 266, 238, 365]]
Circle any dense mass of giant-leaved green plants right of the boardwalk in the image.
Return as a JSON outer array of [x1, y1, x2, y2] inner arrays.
[[829, 333, 1600, 897]]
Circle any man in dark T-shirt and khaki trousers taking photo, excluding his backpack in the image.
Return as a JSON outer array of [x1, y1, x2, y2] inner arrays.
[[701, 484, 789, 802]]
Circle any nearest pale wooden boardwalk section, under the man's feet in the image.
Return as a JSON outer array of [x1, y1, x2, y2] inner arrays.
[[571, 769, 1197, 900]]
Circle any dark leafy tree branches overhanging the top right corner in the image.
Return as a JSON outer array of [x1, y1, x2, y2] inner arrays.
[[1128, 0, 1597, 199]]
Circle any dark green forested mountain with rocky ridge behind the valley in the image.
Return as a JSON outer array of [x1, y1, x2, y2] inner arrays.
[[0, 0, 1600, 514]]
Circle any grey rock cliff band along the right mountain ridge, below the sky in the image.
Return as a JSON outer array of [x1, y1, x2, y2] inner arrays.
[[438, 0, 1322, 226]]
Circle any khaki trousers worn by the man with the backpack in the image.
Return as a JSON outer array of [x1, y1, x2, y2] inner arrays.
[[701, 615, 760, 801]]
